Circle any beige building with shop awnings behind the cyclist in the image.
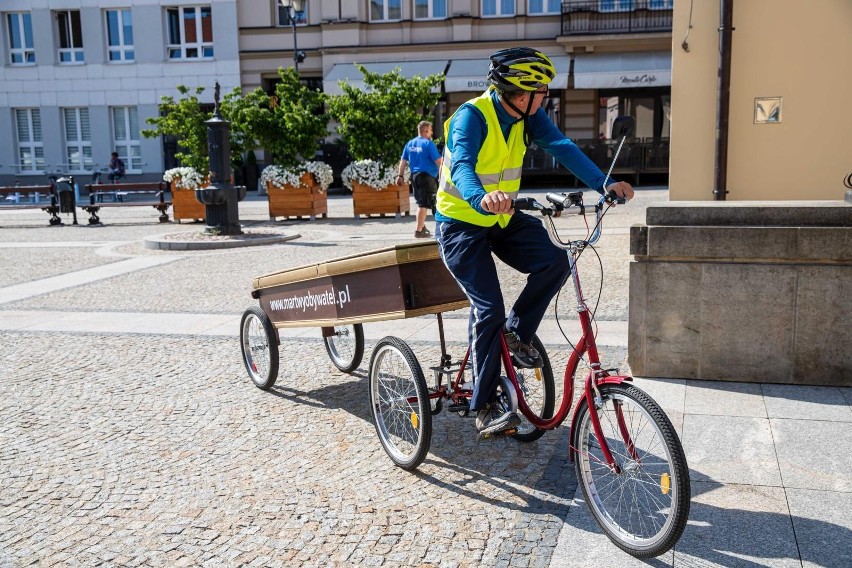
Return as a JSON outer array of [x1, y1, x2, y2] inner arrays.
[[238, 0, 673, 180]]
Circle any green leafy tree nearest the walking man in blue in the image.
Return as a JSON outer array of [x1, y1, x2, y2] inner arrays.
[[328, 65, 443, 168]]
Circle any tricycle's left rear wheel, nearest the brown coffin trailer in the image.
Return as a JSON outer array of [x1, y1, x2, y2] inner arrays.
[[370, 337, 432, 469]]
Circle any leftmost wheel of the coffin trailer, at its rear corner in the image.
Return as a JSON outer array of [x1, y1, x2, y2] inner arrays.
[[240, 306, 278, 390]]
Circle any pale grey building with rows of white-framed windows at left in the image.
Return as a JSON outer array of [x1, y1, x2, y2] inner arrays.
[[0, 0, 240, 185]]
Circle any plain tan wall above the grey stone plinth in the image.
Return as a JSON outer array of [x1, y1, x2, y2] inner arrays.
[[670, 0, 852, 200]]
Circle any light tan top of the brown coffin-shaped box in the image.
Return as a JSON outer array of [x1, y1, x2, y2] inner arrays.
[[252, 241, 440, 290]]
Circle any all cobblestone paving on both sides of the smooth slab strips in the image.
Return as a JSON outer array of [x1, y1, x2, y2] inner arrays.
[[0, 192, 664, 568]]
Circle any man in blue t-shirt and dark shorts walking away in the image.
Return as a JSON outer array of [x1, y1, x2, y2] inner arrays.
[[396, 120, 441, 239]]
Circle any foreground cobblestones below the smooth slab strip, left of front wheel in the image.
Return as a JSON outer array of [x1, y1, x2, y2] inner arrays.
[[0, 333, 576, 566]]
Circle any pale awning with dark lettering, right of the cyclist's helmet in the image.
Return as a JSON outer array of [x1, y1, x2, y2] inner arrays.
[[574, 53, 672, 89]]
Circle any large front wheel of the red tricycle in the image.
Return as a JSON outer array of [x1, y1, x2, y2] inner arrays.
[[572, 384, 690, 558]]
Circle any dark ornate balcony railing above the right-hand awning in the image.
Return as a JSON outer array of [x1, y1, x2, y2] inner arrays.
[[562, 0, 672, 35]]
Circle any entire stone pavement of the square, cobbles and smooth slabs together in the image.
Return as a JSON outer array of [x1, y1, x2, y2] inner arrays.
[[0, 189, 852, 567]]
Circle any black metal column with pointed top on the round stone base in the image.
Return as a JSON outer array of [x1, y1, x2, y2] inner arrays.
[[195, 81, 246, 235]]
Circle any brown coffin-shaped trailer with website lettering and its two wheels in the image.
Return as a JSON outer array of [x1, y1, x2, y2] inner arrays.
[[240, 241, 468, 390]]
